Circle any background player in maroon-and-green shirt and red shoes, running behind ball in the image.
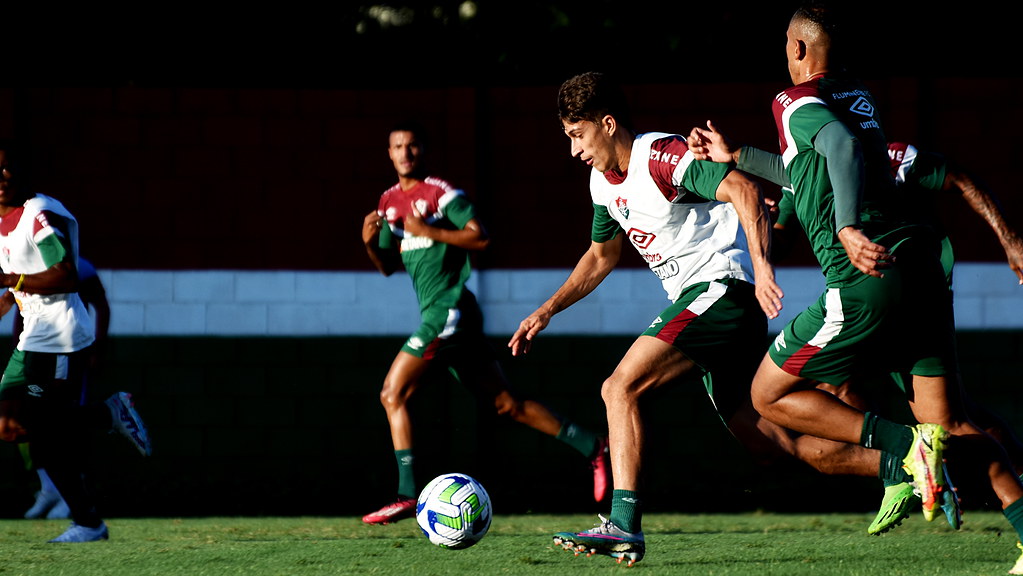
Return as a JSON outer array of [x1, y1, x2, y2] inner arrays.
[[362, 124, 611, 524]]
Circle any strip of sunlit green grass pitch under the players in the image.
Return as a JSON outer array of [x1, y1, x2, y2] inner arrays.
[[0, 512, 1019, 576]]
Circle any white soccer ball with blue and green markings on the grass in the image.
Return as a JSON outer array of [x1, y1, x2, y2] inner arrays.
[[415, 474, 492, 550]]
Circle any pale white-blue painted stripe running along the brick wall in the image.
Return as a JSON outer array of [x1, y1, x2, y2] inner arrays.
[[0, 263, 1010, 337]]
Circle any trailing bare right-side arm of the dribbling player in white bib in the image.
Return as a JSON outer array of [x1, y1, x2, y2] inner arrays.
[[717, 171, 785, 318]]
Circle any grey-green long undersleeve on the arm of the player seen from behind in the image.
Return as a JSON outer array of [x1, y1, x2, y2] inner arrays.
[[813, 121, 865, 230]]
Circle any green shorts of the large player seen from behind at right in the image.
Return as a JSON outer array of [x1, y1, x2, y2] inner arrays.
[[768, 242, 957, 386]]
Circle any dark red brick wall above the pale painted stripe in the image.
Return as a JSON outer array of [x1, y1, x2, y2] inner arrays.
[[0, 79, 1023, 270]]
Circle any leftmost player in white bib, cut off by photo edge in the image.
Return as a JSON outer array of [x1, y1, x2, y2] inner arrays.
[[0, 143, 150, 542]]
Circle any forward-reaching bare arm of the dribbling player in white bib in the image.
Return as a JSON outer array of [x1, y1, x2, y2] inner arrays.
[[508, 234, 623, 356]]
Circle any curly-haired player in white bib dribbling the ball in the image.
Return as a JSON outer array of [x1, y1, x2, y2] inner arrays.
[[508, 73, 787, 564]]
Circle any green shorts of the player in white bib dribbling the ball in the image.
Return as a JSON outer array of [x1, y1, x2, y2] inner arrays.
[[642, 279, 767, 423]]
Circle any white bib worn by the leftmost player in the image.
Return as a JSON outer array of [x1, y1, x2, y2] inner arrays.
[[0, 194, 95, 354]]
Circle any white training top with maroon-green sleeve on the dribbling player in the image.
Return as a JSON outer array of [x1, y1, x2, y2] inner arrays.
[[590, 132, 754, 302]]
